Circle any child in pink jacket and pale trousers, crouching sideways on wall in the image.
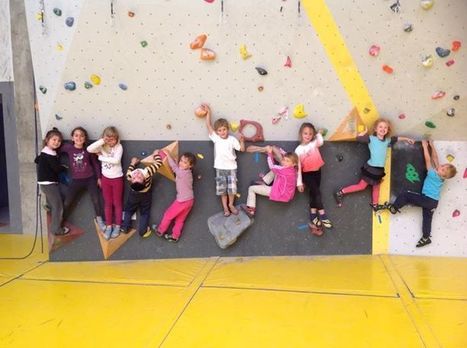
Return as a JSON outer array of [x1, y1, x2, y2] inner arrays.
[[244, 146, 298, 217]]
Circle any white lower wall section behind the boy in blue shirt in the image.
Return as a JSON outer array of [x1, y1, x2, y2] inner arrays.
[[389, 141, 467, 257]]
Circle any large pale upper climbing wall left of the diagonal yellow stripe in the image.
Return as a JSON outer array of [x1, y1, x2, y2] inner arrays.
[[24, 0, 352, 140]]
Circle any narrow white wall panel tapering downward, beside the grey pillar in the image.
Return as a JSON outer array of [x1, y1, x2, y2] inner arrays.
[[24, 0, 83, 133]]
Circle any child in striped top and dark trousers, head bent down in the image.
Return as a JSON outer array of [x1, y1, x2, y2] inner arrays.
[[120, 150, 162, 238]]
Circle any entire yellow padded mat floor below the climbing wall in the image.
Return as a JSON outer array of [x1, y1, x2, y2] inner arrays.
[[0, 235, 467, 348]]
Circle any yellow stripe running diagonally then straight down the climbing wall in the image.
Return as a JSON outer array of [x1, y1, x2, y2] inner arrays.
[[302, 0, 391, 254]]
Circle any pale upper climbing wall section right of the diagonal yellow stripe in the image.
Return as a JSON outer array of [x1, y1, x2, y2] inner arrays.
[[326, 0, 467, 140]]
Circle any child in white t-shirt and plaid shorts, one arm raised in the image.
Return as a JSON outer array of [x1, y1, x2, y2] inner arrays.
[[202, 104, 245, 217]]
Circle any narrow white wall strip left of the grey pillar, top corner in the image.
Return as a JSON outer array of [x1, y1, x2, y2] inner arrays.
[[0, 1, 13, 82]]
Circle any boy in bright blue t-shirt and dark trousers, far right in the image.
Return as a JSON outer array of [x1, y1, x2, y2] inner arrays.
[[387, 140, 457, 248]]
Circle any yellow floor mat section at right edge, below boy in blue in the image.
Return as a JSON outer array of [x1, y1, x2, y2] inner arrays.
[[390, 256, 467, 300]]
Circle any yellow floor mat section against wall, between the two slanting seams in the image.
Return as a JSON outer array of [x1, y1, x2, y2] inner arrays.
[[203, 256, 397, 296]]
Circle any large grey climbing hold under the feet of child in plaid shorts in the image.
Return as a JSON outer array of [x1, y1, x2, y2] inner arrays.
[[208, 206, 254, 249]]
